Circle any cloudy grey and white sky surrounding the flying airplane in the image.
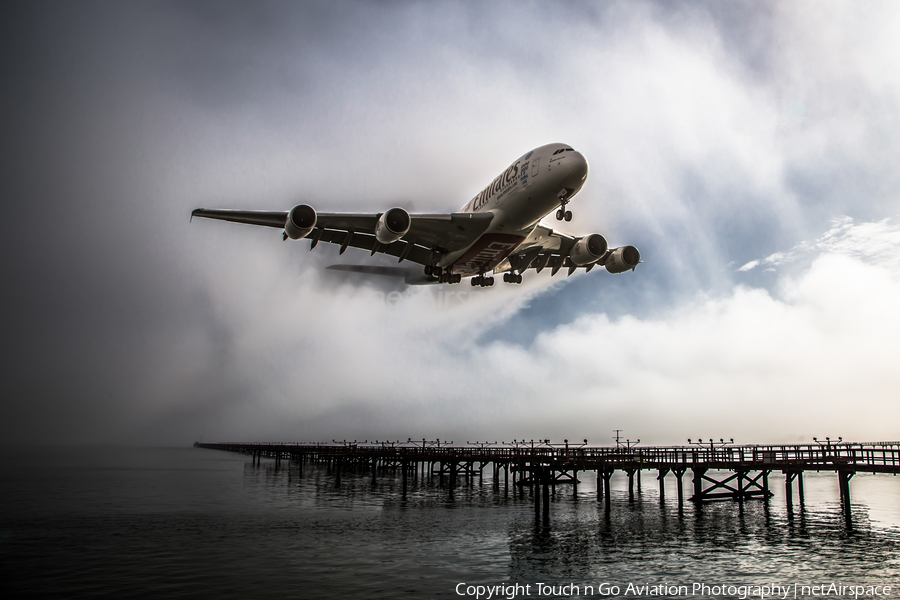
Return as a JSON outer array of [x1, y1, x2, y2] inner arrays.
[[0, 1, 900, 445]]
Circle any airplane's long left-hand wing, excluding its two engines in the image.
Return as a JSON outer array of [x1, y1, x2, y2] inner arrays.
[[191, 208, 493, 265]]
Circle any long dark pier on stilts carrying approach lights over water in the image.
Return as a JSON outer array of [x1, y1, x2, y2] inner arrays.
[[194, 440, 900, 521]]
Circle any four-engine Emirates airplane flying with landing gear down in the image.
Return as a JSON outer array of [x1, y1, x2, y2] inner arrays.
[[191, 144, 642, 287]]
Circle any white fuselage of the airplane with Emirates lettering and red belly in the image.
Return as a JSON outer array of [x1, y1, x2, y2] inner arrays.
[[440, 144, 588, 276]]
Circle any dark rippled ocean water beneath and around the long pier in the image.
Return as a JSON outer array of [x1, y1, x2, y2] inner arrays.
[[0, 448, 900, 599]]
